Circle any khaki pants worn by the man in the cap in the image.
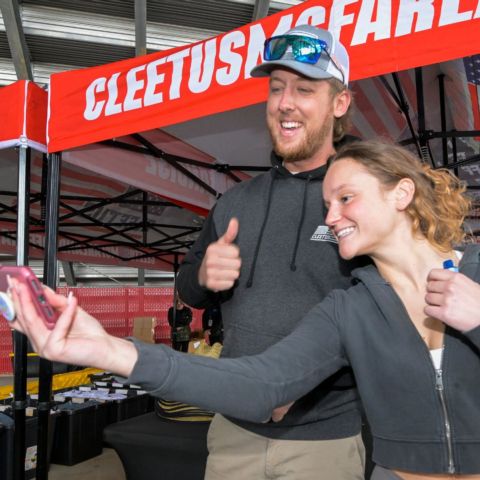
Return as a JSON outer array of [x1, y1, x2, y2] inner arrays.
[[205, 415, 365, 480]]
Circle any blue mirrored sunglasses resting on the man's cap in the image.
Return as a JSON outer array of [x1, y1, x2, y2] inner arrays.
[[263, 35, 345, 83]]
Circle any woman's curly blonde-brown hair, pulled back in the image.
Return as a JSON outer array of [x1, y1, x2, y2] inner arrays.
[[331, 140, 471, 252]]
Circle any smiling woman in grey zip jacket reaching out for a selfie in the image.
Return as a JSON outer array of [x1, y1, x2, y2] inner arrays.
[[8, 142, 480, 480]]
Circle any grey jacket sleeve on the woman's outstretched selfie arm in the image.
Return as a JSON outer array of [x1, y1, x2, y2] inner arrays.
[[126, 297, 348, 422]]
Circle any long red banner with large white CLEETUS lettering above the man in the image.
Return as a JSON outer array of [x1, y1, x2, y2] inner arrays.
[[48, 0, 480, 152]]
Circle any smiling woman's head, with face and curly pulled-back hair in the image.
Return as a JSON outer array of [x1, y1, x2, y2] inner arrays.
[[324, 142, 470, 258]]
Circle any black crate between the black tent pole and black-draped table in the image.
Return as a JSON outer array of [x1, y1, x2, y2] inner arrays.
[[52, 401, 106, 465]]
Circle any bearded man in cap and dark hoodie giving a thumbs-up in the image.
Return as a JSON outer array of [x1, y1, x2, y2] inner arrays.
[[177, 25, 364, 480]]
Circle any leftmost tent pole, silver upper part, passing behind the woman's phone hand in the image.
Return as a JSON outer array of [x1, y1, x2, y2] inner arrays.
[[13, 146, 31, 480]]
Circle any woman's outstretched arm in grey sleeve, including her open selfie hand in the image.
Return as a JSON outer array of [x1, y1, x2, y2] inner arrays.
[[7, 283, 348, 422]]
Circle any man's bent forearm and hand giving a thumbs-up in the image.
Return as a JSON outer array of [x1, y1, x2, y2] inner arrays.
[[176, 209, 241, 308]]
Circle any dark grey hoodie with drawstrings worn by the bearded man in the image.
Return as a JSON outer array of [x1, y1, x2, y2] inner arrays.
[[177, 150, 368, 440]]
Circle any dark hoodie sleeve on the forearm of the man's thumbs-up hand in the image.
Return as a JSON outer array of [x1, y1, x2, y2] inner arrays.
[[176, 207, 218, 308]]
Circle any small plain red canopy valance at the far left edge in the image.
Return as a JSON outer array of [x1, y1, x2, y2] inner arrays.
[[0, 80, 47, 152]]
